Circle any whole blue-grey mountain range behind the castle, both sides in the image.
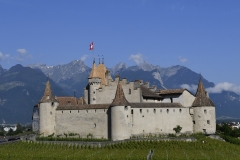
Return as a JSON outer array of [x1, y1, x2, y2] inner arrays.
[[0, 60, 240, 123]]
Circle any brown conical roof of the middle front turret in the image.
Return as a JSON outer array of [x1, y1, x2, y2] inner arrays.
[[111, 83, 130, 106]]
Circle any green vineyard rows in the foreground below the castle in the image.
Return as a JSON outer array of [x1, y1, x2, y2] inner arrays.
[[0, 136, 240, 160]]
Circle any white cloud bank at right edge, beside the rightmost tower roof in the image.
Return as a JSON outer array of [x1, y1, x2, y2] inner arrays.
[[206, 82, 240, 95]]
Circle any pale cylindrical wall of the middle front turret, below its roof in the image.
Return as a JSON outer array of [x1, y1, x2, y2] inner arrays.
[[111, 106, 132, 141]]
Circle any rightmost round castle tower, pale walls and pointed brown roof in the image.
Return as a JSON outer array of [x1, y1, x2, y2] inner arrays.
[[192, 79, 216, 134]]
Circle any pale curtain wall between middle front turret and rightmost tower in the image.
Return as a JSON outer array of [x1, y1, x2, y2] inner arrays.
[[131, 108, 193, 135]]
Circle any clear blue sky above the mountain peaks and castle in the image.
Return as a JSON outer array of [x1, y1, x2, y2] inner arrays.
[[0, 0, 240, 88]]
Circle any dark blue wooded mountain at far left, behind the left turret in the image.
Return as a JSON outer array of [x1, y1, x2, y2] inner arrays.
[[0, 65, 67, 123]]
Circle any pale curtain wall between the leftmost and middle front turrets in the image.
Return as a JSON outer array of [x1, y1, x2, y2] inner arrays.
[[56, 109, 108, 138]]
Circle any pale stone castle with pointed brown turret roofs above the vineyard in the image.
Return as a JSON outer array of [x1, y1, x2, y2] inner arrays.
[[32, 59, 216, 141]]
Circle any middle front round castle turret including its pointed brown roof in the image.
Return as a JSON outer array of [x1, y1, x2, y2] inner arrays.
[[111, 83, 132, 141]]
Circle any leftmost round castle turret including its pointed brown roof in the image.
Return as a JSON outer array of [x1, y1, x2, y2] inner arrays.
[[39, 80, 58, 136]]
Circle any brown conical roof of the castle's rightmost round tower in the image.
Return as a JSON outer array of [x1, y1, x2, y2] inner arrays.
[[192, 78, 215, 107]]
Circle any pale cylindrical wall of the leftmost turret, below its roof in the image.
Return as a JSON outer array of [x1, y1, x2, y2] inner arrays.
[[39, 102, 59, 136]]
